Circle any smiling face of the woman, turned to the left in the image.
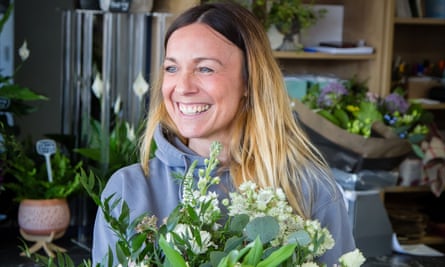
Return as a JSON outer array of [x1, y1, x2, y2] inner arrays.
[[162, 23, 246, 154]]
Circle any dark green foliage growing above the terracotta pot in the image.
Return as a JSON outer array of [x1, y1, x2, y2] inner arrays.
[[0, 131, 82, 201]]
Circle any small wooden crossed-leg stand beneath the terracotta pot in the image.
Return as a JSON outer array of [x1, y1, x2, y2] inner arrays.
[[20, 228, 66, 257]]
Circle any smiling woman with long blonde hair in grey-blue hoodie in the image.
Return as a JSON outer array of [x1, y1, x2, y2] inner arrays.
[[93, 2, 355, 266]]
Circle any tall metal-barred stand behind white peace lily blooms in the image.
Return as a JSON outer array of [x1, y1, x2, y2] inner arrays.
[[61, 10, 171, 250]]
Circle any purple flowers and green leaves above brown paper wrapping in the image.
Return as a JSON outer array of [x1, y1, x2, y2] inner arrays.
[[302, 79, 432, 144]]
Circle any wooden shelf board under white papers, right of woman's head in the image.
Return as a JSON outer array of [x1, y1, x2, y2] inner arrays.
[[274, 51, 376, 60]]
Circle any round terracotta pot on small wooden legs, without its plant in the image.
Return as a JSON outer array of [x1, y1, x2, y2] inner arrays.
[[18, 199, 70, 235]]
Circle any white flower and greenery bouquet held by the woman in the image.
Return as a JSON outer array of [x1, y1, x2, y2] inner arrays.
[[78, 143, 365, 267]]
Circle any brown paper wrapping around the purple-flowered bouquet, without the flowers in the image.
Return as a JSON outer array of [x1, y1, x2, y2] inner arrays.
[[293, 100, 412, 173]]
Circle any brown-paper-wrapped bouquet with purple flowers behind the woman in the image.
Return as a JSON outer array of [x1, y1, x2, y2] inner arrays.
[[292, 78, 433, 173]]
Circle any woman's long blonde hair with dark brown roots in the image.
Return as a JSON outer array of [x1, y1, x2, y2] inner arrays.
[[140, 3, 334, 218]]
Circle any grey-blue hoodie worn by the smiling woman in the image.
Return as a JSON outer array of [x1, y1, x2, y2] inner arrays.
[[92, 126, 355, 266]]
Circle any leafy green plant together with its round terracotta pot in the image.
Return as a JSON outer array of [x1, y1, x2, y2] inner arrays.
[[0, 133, 82, 241]]
